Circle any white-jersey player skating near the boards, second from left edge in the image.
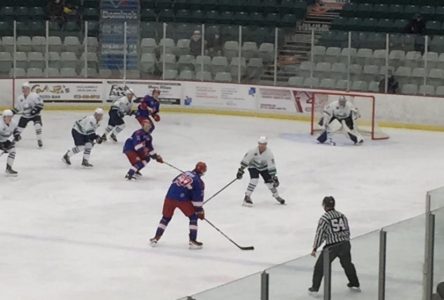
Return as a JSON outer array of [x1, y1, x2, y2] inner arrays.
[[12, 82, 43, 148]]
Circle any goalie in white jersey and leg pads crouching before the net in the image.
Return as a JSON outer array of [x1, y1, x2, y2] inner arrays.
[[317, 96, 364, 145]]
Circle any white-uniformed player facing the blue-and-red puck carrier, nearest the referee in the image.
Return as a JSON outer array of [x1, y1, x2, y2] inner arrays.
[[236, 136, 285, 207]]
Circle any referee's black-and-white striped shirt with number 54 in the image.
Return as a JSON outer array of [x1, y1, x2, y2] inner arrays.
[[313, 209, 350, 250]]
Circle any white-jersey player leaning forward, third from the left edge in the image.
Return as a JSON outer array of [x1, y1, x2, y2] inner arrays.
[[62, 108, 103, 168]]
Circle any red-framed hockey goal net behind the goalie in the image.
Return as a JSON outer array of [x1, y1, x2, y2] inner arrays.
[[310, 92, 389, 140]]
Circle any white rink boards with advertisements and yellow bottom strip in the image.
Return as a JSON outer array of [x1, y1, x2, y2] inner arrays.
[[0, 78, 444, 131]]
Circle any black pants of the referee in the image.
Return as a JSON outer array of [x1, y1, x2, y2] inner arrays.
[[312, 241, 359, 291]]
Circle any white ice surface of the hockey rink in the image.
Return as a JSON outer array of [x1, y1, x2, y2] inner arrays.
[[0, 111, 444, 300]]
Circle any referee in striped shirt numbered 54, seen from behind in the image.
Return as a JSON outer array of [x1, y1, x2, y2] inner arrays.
[[308, 196, 359, 293]]
